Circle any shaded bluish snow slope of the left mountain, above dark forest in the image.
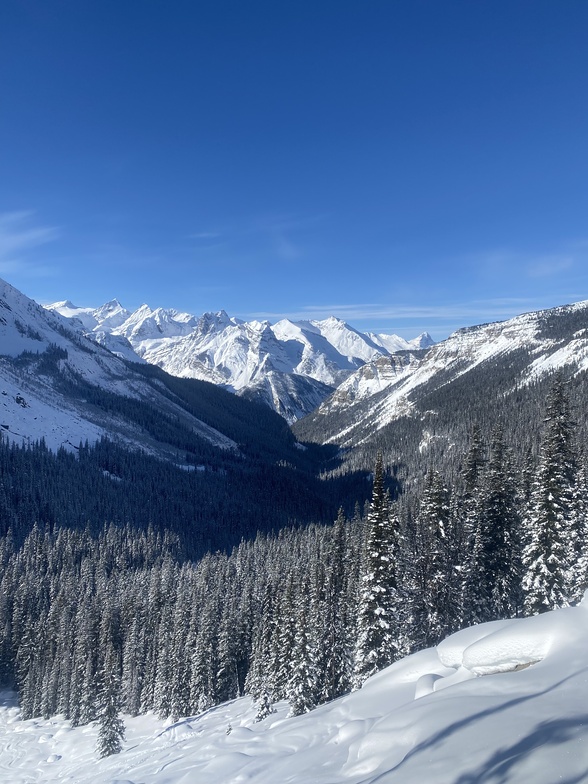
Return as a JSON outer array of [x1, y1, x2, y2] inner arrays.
[[0, 280, 235, 456]]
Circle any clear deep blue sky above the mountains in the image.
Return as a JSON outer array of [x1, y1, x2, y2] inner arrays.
[[0, 0, 588, 339]]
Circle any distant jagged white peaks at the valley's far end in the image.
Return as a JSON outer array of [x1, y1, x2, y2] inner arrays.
[[47, 300, 433, 423]]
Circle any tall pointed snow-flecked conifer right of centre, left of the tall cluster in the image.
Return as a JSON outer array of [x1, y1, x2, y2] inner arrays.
[[353, 454, 398, 689]]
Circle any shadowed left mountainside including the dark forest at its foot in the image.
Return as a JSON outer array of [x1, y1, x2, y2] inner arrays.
[[0, 280, 369, 557]]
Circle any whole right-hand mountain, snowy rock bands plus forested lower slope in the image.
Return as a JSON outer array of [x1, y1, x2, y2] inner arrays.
[[294, 302, 588, 469]]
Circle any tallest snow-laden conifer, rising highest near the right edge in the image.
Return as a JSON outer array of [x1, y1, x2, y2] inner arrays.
[[523, 374, 576, 615]]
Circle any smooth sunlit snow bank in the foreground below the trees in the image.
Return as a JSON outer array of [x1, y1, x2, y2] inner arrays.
[[0, 600, 588, 784]]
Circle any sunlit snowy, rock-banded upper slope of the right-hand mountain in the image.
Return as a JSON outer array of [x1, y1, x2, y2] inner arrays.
[[297, 302, 588, 444]]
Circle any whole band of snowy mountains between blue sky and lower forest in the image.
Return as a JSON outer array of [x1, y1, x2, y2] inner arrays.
[[0, 282, 588, 484]]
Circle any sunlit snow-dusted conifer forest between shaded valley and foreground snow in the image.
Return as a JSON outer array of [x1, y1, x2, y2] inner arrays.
[[0, 376, 588, 755]]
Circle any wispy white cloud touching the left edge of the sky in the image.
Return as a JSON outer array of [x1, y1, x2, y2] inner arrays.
[[0, 210, 60, 277]]
